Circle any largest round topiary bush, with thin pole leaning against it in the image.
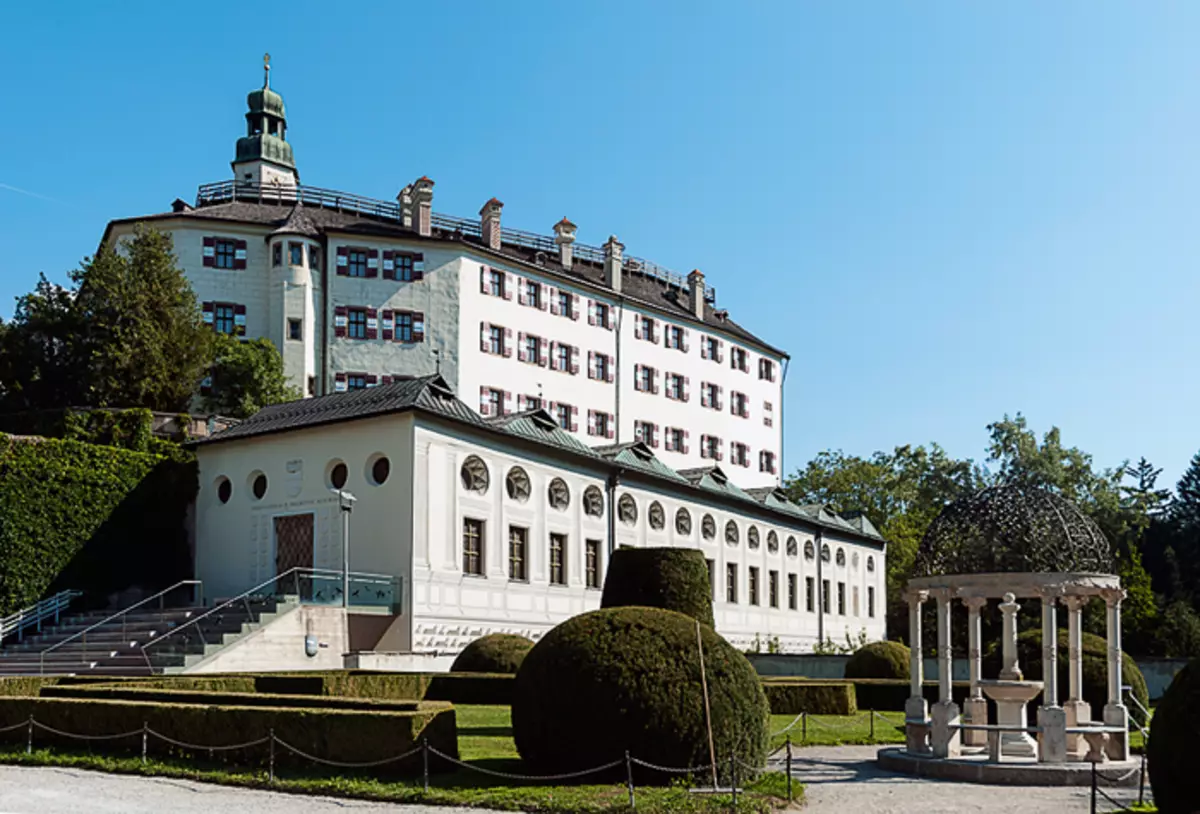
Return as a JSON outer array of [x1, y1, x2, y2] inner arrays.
[[512, 607, 770, 782]]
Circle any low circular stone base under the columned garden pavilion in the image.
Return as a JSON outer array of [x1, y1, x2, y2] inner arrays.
[[877, 747, 1141, 788]]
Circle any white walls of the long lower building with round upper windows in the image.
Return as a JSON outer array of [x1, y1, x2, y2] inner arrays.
[[197, 376, 887, 653]]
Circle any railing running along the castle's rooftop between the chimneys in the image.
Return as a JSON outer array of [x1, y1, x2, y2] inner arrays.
[[196, 180, 716, 305]]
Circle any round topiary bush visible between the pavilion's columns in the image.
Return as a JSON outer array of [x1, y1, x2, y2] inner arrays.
[[984, 629, 1150, 724]]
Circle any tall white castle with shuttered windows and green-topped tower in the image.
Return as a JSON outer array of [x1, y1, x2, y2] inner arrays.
[[104, 67, 788, 487]]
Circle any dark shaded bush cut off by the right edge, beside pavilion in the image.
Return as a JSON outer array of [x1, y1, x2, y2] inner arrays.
[[1146, 659, 1200, 814]]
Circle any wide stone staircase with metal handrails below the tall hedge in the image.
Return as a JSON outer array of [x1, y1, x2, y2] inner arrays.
[[0, 597, 300, 677]]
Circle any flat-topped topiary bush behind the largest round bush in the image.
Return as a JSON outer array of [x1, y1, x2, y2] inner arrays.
[[600, 549, 713, 627]]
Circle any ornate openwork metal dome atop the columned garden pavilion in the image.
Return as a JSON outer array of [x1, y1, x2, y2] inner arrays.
[[916, 486, 1112, 576]]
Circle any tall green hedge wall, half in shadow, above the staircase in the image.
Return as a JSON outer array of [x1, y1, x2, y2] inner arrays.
[[0, 435, 197, 615]]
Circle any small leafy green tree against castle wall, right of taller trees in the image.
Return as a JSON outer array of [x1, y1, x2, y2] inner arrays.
[[203, 334, 300, 418]]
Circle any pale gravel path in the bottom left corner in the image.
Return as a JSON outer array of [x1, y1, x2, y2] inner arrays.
[[0, 766, 479, 814]]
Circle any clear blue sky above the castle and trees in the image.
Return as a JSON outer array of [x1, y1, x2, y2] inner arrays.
[[0, 0, 1200, 485]]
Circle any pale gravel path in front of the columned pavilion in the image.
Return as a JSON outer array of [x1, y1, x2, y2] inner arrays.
[[793, 746, 1138, 814]]
